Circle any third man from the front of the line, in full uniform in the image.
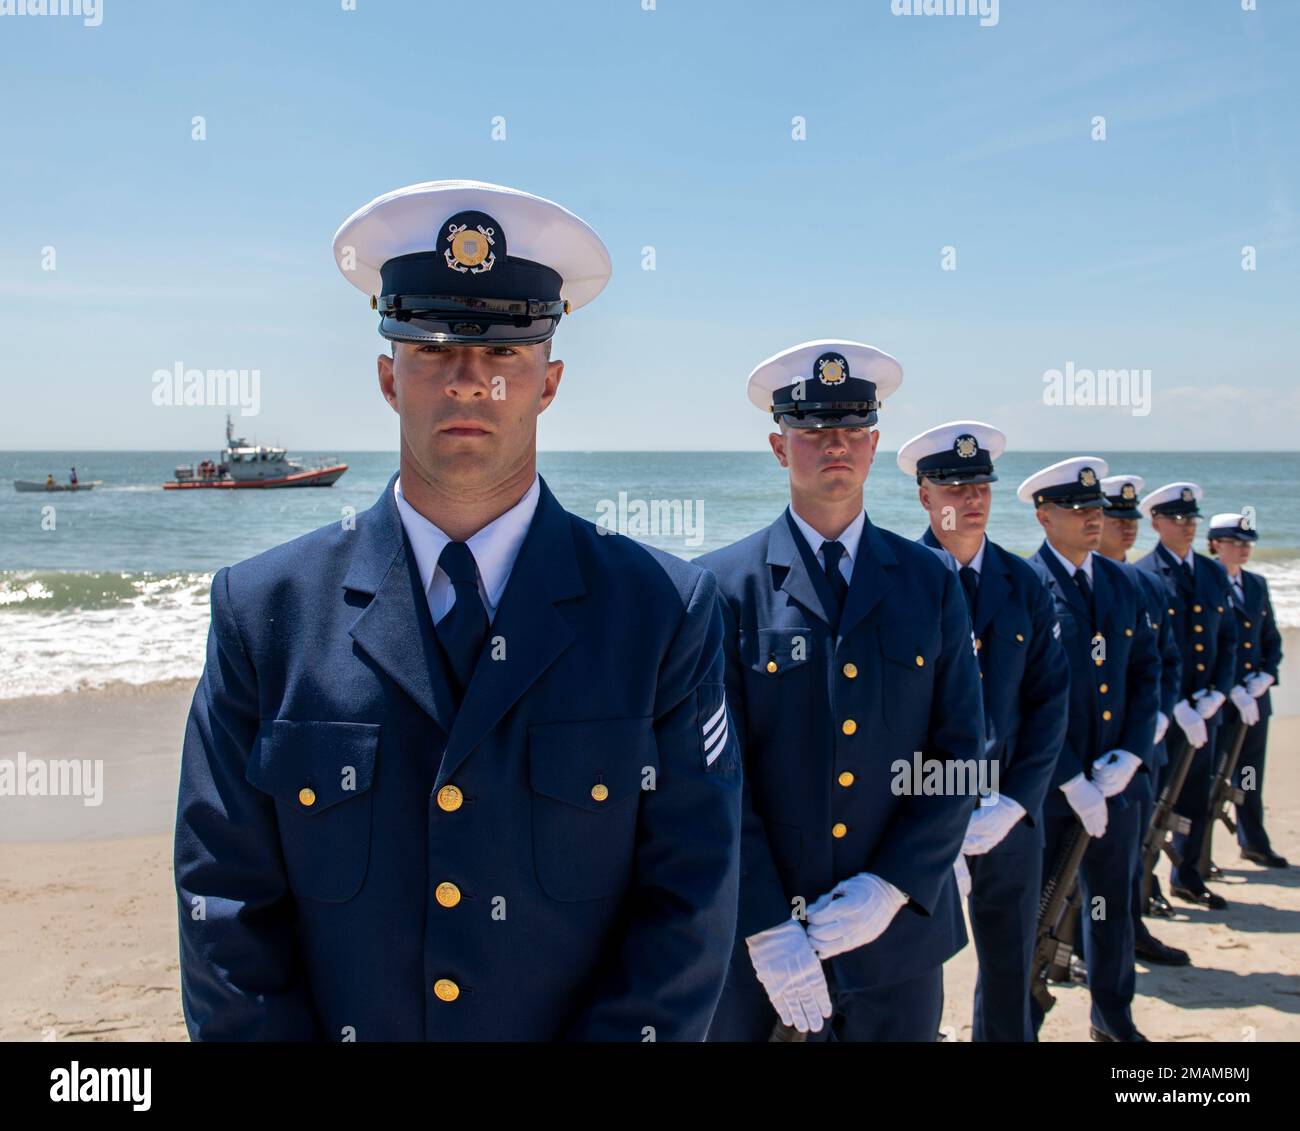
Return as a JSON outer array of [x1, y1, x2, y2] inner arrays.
[[897, 420, 1070, 1041]]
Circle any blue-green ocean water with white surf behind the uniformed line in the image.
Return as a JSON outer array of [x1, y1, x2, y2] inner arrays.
[[0, 451, 1300, 699]]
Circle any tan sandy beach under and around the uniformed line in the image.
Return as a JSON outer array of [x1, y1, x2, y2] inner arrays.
[[0, 676, 1300, 1041]]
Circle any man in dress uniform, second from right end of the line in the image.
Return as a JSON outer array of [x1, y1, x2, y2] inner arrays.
[[1135, 481, 1236, 911]]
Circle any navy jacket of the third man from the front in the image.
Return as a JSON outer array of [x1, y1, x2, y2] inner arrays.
[[920, 528, 1070, 824]]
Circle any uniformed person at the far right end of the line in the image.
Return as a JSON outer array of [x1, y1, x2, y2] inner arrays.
[[1208, 514, 1287, 868]]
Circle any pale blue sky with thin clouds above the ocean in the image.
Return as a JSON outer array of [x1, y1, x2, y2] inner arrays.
[[0, 0, 1300, 451]]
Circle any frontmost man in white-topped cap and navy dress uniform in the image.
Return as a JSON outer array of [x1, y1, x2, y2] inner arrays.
[[176, 181, 741, 1041]]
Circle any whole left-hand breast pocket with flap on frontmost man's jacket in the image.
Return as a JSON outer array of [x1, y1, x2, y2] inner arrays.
[[244, 719, 380, 904]]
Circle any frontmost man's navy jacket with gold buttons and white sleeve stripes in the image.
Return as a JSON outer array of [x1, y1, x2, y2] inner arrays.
[[176, 481, 741, 1041]]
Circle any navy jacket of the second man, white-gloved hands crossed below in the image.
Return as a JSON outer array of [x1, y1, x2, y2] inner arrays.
[[697, 512, 984, 991]]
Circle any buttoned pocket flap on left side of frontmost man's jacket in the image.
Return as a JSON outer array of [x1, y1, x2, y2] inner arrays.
[[244, 719, 380, 814]]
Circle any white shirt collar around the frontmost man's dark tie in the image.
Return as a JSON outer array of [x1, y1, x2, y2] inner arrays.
[[393, 475, 542, 624]]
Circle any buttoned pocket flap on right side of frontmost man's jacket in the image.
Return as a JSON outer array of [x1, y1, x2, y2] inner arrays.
[[528, 718, 659, 813]]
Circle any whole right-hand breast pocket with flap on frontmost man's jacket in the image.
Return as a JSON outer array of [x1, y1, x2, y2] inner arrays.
[[528, 718, 659, 902]]
